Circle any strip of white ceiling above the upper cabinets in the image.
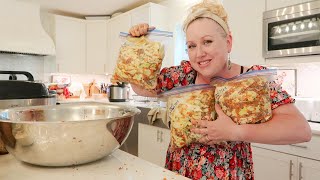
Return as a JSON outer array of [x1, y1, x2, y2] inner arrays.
[[18, 0, 164, 17]]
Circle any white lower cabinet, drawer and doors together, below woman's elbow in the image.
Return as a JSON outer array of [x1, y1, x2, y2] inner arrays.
[[252, 135, 320, 180]]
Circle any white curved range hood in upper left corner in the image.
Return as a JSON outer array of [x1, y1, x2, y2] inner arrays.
[[0, 0, 55, 55]]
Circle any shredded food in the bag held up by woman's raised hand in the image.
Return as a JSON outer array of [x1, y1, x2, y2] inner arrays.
[[111, 36, 164, 90]]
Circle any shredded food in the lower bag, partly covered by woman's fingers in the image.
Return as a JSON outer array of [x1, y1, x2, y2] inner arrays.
[[167, 89, 215, 148]]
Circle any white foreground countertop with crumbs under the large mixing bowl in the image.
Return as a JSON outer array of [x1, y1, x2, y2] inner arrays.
[[0, 150, 188, 180]]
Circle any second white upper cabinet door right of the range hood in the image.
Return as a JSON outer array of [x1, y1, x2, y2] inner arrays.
[[86, 20, 107, 74]]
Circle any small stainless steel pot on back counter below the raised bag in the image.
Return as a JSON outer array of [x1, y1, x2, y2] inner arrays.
[[108, 83, 129, 102]]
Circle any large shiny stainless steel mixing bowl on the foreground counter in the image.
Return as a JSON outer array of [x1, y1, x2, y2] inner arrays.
[[0, 103, 140, 166]]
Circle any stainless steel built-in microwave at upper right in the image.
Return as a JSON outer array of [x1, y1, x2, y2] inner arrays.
[[263, 0, 320, 58]]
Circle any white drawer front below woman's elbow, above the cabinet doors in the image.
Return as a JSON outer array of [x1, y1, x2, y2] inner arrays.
[[251, 135, 320, 160]]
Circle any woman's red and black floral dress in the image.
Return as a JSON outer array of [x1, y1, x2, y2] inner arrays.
[[157, 61, 294, 180]]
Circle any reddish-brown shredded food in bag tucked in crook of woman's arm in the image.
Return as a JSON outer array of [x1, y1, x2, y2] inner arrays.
[[213, 76, 272, 124]]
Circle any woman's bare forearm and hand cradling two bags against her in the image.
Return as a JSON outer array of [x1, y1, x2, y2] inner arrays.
[[192, 104, 312, 145]]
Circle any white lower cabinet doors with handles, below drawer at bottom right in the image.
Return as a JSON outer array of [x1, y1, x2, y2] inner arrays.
[[252, 147, 320, 180]]
